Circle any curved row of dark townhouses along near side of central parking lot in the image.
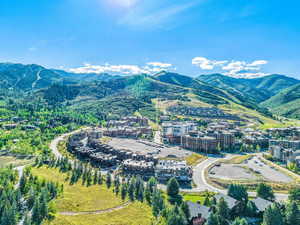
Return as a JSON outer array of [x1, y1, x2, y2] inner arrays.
[[67, 129, 192, 182]]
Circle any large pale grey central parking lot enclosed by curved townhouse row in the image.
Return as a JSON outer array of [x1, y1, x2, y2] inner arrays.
[[107, 138, 191, 158]]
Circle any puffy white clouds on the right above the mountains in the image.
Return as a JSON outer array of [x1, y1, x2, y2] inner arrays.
[[192, 57, 268, 78]]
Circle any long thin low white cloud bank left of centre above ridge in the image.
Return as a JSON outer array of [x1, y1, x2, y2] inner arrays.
[[69, 62, 175, 75]]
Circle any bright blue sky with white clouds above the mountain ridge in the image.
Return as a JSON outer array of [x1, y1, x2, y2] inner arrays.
[[0, 0, 300, 79]]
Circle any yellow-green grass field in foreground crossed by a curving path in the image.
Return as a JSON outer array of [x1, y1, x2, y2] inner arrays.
[[32, 166, 152, 225]]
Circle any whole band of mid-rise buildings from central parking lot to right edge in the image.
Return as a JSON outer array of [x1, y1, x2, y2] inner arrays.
[[162, 120, 300, 159]]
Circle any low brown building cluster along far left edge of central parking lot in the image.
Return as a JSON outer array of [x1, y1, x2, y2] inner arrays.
[[103, 116, 153, 138]]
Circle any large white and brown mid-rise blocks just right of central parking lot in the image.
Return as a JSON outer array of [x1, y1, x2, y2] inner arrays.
[[162, 122, 235, 153]]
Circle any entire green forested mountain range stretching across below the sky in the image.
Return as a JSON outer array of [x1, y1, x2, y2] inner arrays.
[[0, 63, 300, 121]]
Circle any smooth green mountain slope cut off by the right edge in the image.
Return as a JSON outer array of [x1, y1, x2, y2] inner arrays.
[[261, 84, 300, 119]]
